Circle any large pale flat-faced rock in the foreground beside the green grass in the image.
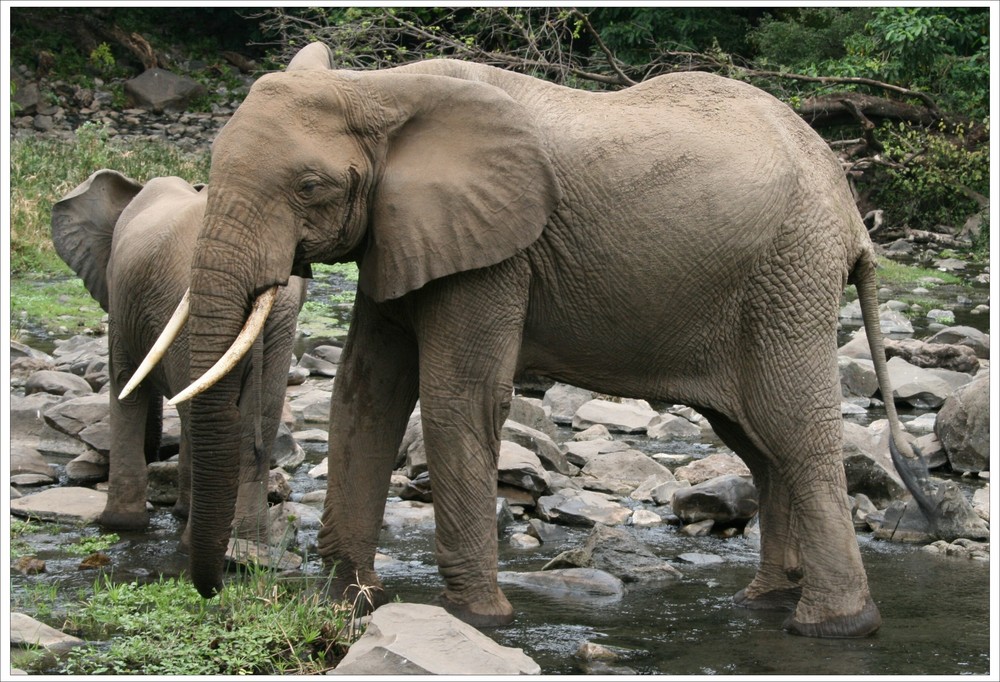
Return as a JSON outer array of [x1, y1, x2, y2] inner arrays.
[[332, 603, 541, 676]]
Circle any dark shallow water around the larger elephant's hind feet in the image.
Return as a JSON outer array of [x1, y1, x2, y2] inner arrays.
[[376, 516, 990, 676]]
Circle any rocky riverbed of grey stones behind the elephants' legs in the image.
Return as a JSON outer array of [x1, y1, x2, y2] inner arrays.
[[10, 305, 989, 672]]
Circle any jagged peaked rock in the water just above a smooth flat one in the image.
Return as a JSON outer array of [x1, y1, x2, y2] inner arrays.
[[542, 524, 681, 583]]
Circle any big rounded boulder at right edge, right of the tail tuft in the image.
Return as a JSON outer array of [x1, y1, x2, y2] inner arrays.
[[934, 376, 990, 472]]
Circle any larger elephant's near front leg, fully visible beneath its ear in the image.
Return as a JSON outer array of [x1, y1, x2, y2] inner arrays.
[[416, 260, 529, 627]]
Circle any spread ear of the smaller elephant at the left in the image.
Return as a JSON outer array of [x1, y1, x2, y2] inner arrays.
[[52, 170, 142, 311]]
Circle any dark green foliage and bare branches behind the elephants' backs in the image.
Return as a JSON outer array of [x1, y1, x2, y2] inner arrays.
[[11, 6, 990, 250]]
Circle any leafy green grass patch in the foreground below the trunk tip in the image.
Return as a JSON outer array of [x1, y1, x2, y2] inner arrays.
[[59, 570, 357, 675]]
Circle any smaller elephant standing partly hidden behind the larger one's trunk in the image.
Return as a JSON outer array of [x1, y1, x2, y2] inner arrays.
[[52, 170, 305, 539]]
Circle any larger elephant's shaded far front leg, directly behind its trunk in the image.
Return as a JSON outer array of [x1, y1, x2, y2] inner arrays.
[[318, 291, 418, 607]]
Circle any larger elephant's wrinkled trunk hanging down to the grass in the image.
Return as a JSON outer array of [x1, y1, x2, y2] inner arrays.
[[188, 227, 262, 598]]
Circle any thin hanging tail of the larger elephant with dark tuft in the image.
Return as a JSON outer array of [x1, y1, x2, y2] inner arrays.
[[849, 250, 937, 528]]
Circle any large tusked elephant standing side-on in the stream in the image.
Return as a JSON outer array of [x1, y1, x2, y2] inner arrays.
[[168, 51, 964, 637]]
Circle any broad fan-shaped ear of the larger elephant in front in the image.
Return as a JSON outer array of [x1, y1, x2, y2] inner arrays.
[[358, 72, 560, 301]]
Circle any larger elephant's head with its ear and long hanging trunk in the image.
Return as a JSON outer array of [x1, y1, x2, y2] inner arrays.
[[182, 62, 559, 596]]
